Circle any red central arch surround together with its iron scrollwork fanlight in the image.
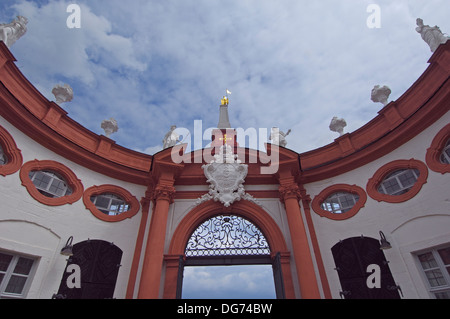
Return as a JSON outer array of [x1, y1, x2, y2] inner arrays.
[[164, 201, 295, 299]]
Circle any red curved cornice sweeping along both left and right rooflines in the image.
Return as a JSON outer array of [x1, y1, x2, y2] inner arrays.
[[0, 41, 450, 185]]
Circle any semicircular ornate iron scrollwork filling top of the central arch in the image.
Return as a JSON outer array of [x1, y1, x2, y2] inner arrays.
[[185, 215, 270, 257]]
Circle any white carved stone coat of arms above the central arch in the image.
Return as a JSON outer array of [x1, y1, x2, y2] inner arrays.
[[196, 145, 259, 207]]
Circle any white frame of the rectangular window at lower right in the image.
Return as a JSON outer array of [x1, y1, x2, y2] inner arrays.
[[414, 244, 450, 299]]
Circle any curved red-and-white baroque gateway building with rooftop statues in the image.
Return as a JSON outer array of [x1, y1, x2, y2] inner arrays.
[[0, 18, 450, 300]]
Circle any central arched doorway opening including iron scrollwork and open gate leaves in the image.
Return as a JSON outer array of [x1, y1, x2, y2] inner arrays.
[[177, 214, 285, 299]]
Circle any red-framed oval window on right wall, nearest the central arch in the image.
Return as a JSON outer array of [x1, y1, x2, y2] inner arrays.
[[311, 184, 367, 220]]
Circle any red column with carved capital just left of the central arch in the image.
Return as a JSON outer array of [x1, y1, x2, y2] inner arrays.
[[138, 181, 175, 299]]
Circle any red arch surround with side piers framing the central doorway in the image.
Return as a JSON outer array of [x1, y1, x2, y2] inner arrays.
[[164, 200, 295, 299]]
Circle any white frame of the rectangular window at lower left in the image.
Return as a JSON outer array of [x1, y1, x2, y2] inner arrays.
[[0, 250, 39, 299]]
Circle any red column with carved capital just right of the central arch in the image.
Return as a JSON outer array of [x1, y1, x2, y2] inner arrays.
[[279, 178, 320, 299]]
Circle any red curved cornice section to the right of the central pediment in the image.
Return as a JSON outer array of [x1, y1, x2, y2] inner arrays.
[[298, 41, 450, 184]]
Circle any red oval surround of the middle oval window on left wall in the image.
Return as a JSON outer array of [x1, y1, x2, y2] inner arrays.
[[20, 160, 83, 206]]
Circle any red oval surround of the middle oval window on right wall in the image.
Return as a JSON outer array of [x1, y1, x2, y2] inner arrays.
[[366, 159, 428, 203]]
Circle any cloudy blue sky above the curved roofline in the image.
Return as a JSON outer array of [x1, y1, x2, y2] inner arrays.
[[0, 0, 450, 300]]
